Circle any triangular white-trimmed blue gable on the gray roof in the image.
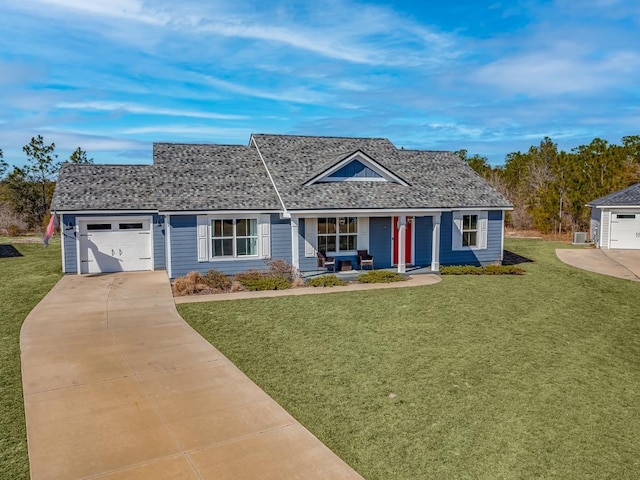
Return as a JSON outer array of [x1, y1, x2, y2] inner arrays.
[[305, 150, 408, 186]]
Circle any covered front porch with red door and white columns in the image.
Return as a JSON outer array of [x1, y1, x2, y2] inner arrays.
[[289, 211, 442, 276]]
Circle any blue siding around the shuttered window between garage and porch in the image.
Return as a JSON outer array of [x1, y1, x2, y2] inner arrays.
[[170, 214, 291, 278]]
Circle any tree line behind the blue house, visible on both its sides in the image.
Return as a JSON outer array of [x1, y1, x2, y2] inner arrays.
[[0, 135, 640, 233]]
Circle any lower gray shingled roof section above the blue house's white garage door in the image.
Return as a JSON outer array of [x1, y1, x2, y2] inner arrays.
[[51, 164, 158, 211]]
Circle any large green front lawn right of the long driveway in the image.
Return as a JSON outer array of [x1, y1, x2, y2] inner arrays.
[[179, 240, 640, 480]]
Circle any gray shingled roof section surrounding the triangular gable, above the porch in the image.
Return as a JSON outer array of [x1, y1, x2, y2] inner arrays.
[[253, 135, 511, 210]]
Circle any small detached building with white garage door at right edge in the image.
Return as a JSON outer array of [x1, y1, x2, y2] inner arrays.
[[587, 183, 640, 249]]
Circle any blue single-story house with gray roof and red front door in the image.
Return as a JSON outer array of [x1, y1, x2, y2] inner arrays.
[[51, 134, 512, 278]]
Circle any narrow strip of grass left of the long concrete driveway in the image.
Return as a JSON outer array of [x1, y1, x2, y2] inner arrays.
[[0, 237, 62, 480]]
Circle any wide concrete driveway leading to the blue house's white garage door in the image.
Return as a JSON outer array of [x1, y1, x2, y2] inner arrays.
[[20, 272, 361, 480]]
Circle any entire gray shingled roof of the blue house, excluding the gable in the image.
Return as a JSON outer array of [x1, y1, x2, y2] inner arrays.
[[51, 135, 511, 211]]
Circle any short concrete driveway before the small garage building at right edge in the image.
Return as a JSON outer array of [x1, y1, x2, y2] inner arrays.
[[556, 248, 640, 282]]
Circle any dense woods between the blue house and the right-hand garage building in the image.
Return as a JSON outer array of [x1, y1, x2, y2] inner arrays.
[[457, 135, 640, 233]]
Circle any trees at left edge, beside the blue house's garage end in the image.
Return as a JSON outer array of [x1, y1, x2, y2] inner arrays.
[[0, 135, 93, 234]]
